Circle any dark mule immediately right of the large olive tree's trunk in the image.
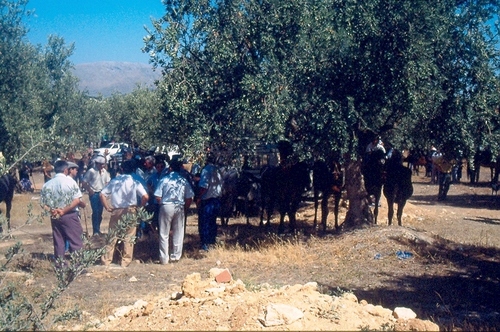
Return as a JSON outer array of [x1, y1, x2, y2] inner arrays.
[[362, 150, 387, 224]]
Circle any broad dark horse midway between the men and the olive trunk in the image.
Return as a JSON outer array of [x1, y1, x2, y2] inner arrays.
[[260, 162, 311, 234]]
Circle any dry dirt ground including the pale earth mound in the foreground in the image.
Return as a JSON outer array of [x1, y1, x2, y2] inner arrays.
[[0, 170, 500, 330]]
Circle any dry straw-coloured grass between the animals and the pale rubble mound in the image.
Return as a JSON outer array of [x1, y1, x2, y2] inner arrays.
[[0, 170, 500, 330]]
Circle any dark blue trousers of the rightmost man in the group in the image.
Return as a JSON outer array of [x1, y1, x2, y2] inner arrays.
[[198, 198, 220, 246]]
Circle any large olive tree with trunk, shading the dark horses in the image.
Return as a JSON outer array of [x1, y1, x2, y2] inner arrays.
[[144, 0, 498, 227]]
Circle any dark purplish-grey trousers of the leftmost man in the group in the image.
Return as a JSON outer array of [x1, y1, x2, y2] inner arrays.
[[50, 212, 83, 259]]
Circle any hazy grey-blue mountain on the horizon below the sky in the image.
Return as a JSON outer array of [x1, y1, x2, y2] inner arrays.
[[73, 61, 161, 97]]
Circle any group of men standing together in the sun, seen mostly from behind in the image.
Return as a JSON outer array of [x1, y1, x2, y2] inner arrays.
[[40, 147, 222, 267]]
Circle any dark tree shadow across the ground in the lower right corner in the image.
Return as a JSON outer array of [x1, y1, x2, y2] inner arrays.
[[321, 237, 500, 331]]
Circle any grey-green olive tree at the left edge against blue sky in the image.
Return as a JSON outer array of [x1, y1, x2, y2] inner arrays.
[[0, 0, 91, 163]]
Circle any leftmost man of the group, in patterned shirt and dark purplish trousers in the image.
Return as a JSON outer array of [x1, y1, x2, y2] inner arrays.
[[40, 160, 83, 259]]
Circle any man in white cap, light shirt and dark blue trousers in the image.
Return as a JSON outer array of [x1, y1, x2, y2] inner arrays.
[[82, 155, 111, 235]]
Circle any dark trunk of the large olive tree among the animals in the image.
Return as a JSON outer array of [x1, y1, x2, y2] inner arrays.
[[342, 160, 374, 229]]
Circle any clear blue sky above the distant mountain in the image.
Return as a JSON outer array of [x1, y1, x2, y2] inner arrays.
[[25, 0, 165, 64]]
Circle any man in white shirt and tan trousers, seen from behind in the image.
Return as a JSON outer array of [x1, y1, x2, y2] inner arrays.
[[100, 160, 149, 267]]
